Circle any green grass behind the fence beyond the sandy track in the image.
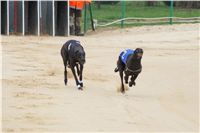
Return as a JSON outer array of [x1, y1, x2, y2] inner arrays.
[[82, 1, 200, 28]]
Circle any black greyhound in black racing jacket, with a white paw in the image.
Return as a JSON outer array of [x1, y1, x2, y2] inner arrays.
[[61, 40, 85, 90]]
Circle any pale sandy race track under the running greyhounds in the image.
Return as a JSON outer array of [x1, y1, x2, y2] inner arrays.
[[1, 24, 200, 132]]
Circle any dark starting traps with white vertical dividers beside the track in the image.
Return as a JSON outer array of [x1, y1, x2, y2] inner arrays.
[[0, 0, 69, 36]]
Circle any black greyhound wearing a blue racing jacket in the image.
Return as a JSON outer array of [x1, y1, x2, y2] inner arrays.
[[114, 48, 143, 93]]
